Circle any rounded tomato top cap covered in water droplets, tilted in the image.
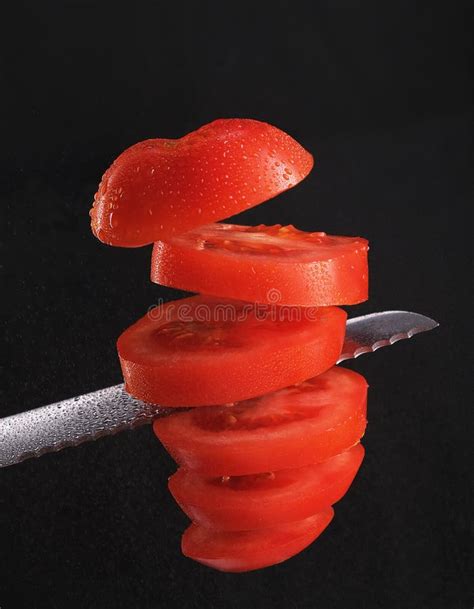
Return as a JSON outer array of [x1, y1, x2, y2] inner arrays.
[[90, 119, 313, 247]]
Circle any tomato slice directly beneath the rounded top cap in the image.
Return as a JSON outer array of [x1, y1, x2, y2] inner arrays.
[[151, 224, 368, 306]]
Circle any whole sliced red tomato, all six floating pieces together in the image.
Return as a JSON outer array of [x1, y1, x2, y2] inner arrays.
[[91, 119, 368, 572]]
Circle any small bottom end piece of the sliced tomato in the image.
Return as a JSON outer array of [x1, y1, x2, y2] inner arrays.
[[181, 508, 334, 573]]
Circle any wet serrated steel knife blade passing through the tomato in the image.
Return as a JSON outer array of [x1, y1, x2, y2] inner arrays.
[[0, 311, 438, 467]]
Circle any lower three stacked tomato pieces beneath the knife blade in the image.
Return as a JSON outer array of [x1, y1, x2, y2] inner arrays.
[[154, 360, 367, 571]]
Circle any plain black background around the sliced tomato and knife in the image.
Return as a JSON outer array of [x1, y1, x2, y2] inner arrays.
[[0, 0, 472, 609]]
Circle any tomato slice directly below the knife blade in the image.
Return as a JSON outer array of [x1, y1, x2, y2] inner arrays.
[[153, 360, 367, 476]]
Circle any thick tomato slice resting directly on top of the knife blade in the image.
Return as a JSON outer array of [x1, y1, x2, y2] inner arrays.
[[117, 296, 346, 404]]
